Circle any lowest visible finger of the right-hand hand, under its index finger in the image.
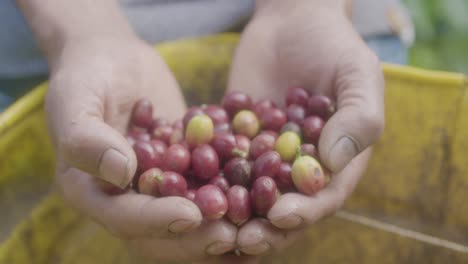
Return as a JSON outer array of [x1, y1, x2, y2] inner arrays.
[[237, 218, 304, 256]]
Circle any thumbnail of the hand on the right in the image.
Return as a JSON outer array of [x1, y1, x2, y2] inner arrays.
[[328, 136, 358, 172]]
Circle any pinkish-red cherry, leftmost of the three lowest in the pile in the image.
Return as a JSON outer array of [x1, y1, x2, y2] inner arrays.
[[194, 184, 228, 220]]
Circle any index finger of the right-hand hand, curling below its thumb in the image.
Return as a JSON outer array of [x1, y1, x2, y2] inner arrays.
[[268, 149, 371, 229]]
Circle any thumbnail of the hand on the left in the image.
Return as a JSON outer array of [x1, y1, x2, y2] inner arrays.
[[99, 149, 131, 189]]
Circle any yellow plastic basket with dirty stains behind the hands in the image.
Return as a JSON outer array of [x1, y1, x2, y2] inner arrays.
[[0, 34, 468, 264]]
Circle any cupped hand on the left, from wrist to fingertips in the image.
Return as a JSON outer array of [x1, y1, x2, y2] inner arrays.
[[45, 36, 237, 261]]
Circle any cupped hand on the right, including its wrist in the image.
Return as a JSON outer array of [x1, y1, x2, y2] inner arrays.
[[228, 0, 384, 255]]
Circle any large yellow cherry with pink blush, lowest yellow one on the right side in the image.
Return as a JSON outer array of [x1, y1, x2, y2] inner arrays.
[[291, 156, 326, 195]]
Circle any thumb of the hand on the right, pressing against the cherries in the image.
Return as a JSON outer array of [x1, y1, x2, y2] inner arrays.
[[319, 54, 385, 172]]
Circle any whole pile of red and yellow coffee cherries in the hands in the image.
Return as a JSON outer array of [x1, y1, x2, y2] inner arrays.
[[104, 88, 334, 225]]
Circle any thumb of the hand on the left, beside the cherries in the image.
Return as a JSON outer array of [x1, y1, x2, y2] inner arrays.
[[59, 116, 137, 188]]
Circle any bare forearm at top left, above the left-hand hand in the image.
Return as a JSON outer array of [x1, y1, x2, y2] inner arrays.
[[16, 0, 135, 65]]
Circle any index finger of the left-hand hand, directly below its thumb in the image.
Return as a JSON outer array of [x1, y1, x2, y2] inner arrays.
[[58, 168, 202, 239]]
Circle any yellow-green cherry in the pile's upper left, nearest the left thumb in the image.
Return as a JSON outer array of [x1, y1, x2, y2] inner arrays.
[[185, 115, 214, 147]]
